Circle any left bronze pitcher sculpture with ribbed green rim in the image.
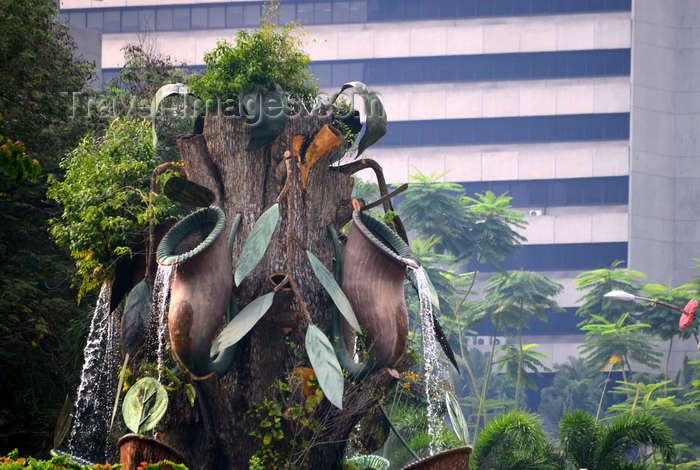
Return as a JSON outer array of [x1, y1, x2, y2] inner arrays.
[[157, 206, 235, 377]]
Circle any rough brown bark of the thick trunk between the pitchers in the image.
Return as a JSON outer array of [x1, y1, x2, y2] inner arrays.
[[157, 116, 409, 470]]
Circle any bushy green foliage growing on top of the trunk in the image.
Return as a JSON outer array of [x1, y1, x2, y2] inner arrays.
[[190, 5, 318, 104]]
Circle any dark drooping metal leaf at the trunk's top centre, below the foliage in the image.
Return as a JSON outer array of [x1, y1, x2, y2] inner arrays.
[[244, 90, 288, 152]]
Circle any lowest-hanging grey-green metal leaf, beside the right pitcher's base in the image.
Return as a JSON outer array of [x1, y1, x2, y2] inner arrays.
[[306, 325, 344, 410]]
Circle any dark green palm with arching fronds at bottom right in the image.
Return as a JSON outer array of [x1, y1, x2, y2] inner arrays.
[[559, 410, 675, 470]]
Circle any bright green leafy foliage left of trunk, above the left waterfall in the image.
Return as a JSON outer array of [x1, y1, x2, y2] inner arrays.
[[47, 118, 175, 296]]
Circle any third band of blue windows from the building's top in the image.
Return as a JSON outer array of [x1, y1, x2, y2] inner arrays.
[[375, 113, 630, 147]]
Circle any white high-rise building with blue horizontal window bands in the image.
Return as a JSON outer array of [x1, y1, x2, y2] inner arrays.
[[61, 0, 700, 374]]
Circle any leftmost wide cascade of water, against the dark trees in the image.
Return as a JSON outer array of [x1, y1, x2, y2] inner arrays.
[[68, 283, 120, 462]]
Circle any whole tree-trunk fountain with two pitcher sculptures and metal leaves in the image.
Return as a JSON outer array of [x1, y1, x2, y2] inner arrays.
[[58, 82, 468, 470]]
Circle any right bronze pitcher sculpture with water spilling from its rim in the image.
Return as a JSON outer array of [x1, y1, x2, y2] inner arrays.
[[342, 210, 416, 368]]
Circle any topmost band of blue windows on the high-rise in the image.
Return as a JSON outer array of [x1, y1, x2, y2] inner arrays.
[[61, 0, 632, 33]]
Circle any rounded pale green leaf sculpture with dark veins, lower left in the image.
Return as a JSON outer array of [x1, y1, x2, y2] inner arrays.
[[122, 377, 168, 434]]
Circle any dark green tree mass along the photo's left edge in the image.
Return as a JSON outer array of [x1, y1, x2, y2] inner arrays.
[[0, 0, 92, 454]]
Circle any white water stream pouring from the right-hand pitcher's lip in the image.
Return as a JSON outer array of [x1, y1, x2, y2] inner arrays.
[[408, 262, 444, 455]]
